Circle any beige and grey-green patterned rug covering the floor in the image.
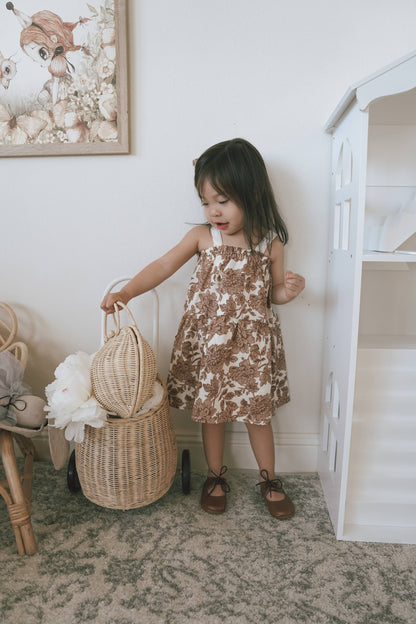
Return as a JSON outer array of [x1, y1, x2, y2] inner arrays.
[[0, 463, 416, 624]]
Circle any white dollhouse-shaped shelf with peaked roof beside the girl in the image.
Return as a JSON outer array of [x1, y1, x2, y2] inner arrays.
[[319, 51, 416, 544]]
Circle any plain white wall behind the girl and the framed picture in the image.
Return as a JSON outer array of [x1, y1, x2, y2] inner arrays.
[[0, 0, 416, 470]]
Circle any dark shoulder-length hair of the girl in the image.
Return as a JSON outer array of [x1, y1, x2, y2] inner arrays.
[[194, 139, 289, 249]]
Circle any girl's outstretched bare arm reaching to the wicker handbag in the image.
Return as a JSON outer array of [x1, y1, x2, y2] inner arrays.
[[101, 226, 205, 314]]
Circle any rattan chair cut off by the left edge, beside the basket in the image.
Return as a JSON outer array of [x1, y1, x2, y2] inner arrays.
[[0, 302, 46, 555]]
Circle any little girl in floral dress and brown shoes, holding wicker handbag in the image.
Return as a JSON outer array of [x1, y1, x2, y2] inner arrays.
[[101, 139, 305, 519]]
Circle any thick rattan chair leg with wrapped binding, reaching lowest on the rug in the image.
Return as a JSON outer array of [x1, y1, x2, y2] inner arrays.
[[0, 430, 36, 555]]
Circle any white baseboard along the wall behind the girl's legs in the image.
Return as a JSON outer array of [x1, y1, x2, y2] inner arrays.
[[33, 430, 319, 472]]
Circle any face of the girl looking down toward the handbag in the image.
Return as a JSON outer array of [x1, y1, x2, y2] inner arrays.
[[201, 180, 244, 236]]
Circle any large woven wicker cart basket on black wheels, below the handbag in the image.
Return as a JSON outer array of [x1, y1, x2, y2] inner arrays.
[[75, 378, 177, 510]]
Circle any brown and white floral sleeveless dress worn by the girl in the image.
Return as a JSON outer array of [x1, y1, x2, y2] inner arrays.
[[168, 228, 290, 425]]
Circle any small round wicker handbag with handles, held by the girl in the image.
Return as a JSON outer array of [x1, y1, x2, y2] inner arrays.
[[91, 302, 157, 418]]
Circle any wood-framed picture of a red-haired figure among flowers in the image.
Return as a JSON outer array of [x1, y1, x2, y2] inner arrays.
[[0, 0, 129, 157]]
